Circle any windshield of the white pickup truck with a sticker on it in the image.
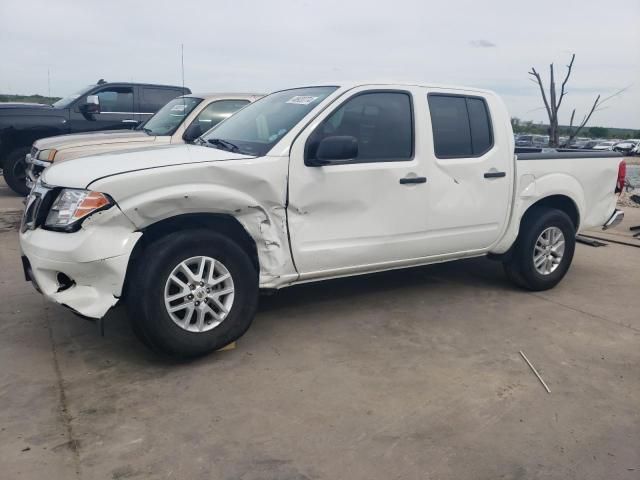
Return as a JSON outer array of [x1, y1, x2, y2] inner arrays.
[[202, 87, 338, 156]]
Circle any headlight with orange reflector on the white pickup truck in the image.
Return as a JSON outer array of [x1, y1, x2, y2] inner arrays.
[[44, 188, 114, 231]]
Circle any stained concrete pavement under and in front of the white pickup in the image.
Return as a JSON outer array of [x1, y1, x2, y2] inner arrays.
[[0, 180, 640, 480]]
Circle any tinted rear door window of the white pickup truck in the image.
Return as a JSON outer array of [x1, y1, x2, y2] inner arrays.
[[428, 94, 493, 158]]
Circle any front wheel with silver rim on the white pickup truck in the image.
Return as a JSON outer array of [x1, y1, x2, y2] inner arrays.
[[126, 230, 258, 358]]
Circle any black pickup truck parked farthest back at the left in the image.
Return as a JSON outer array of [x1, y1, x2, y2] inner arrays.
[[0, 79, 191, 195]]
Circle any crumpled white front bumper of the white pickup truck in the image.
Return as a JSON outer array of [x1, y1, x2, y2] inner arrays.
[[20, 206, 142, 318]]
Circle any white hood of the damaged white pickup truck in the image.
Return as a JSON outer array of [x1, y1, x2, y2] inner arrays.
[[41, 145, 254, 188]]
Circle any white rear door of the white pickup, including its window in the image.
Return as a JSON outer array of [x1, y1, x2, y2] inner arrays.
[[424, 89, 514, 255]]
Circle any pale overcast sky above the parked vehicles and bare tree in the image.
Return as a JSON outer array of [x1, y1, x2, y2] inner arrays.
[[0, 0, 640, 129]]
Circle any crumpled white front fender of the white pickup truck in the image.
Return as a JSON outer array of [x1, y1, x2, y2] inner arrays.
[[91, 157, 297, 288]]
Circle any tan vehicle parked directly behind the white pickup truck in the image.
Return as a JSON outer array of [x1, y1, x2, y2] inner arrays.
[[25, 93, 263, 188]]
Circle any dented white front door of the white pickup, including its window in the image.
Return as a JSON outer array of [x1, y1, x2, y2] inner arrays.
[[287, 86, 428, 279]]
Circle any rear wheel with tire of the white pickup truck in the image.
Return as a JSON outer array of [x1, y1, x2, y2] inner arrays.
[[504, 207, 576, 291]]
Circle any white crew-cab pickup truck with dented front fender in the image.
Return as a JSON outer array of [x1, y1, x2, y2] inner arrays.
[[20, 84, 624, 356]]
